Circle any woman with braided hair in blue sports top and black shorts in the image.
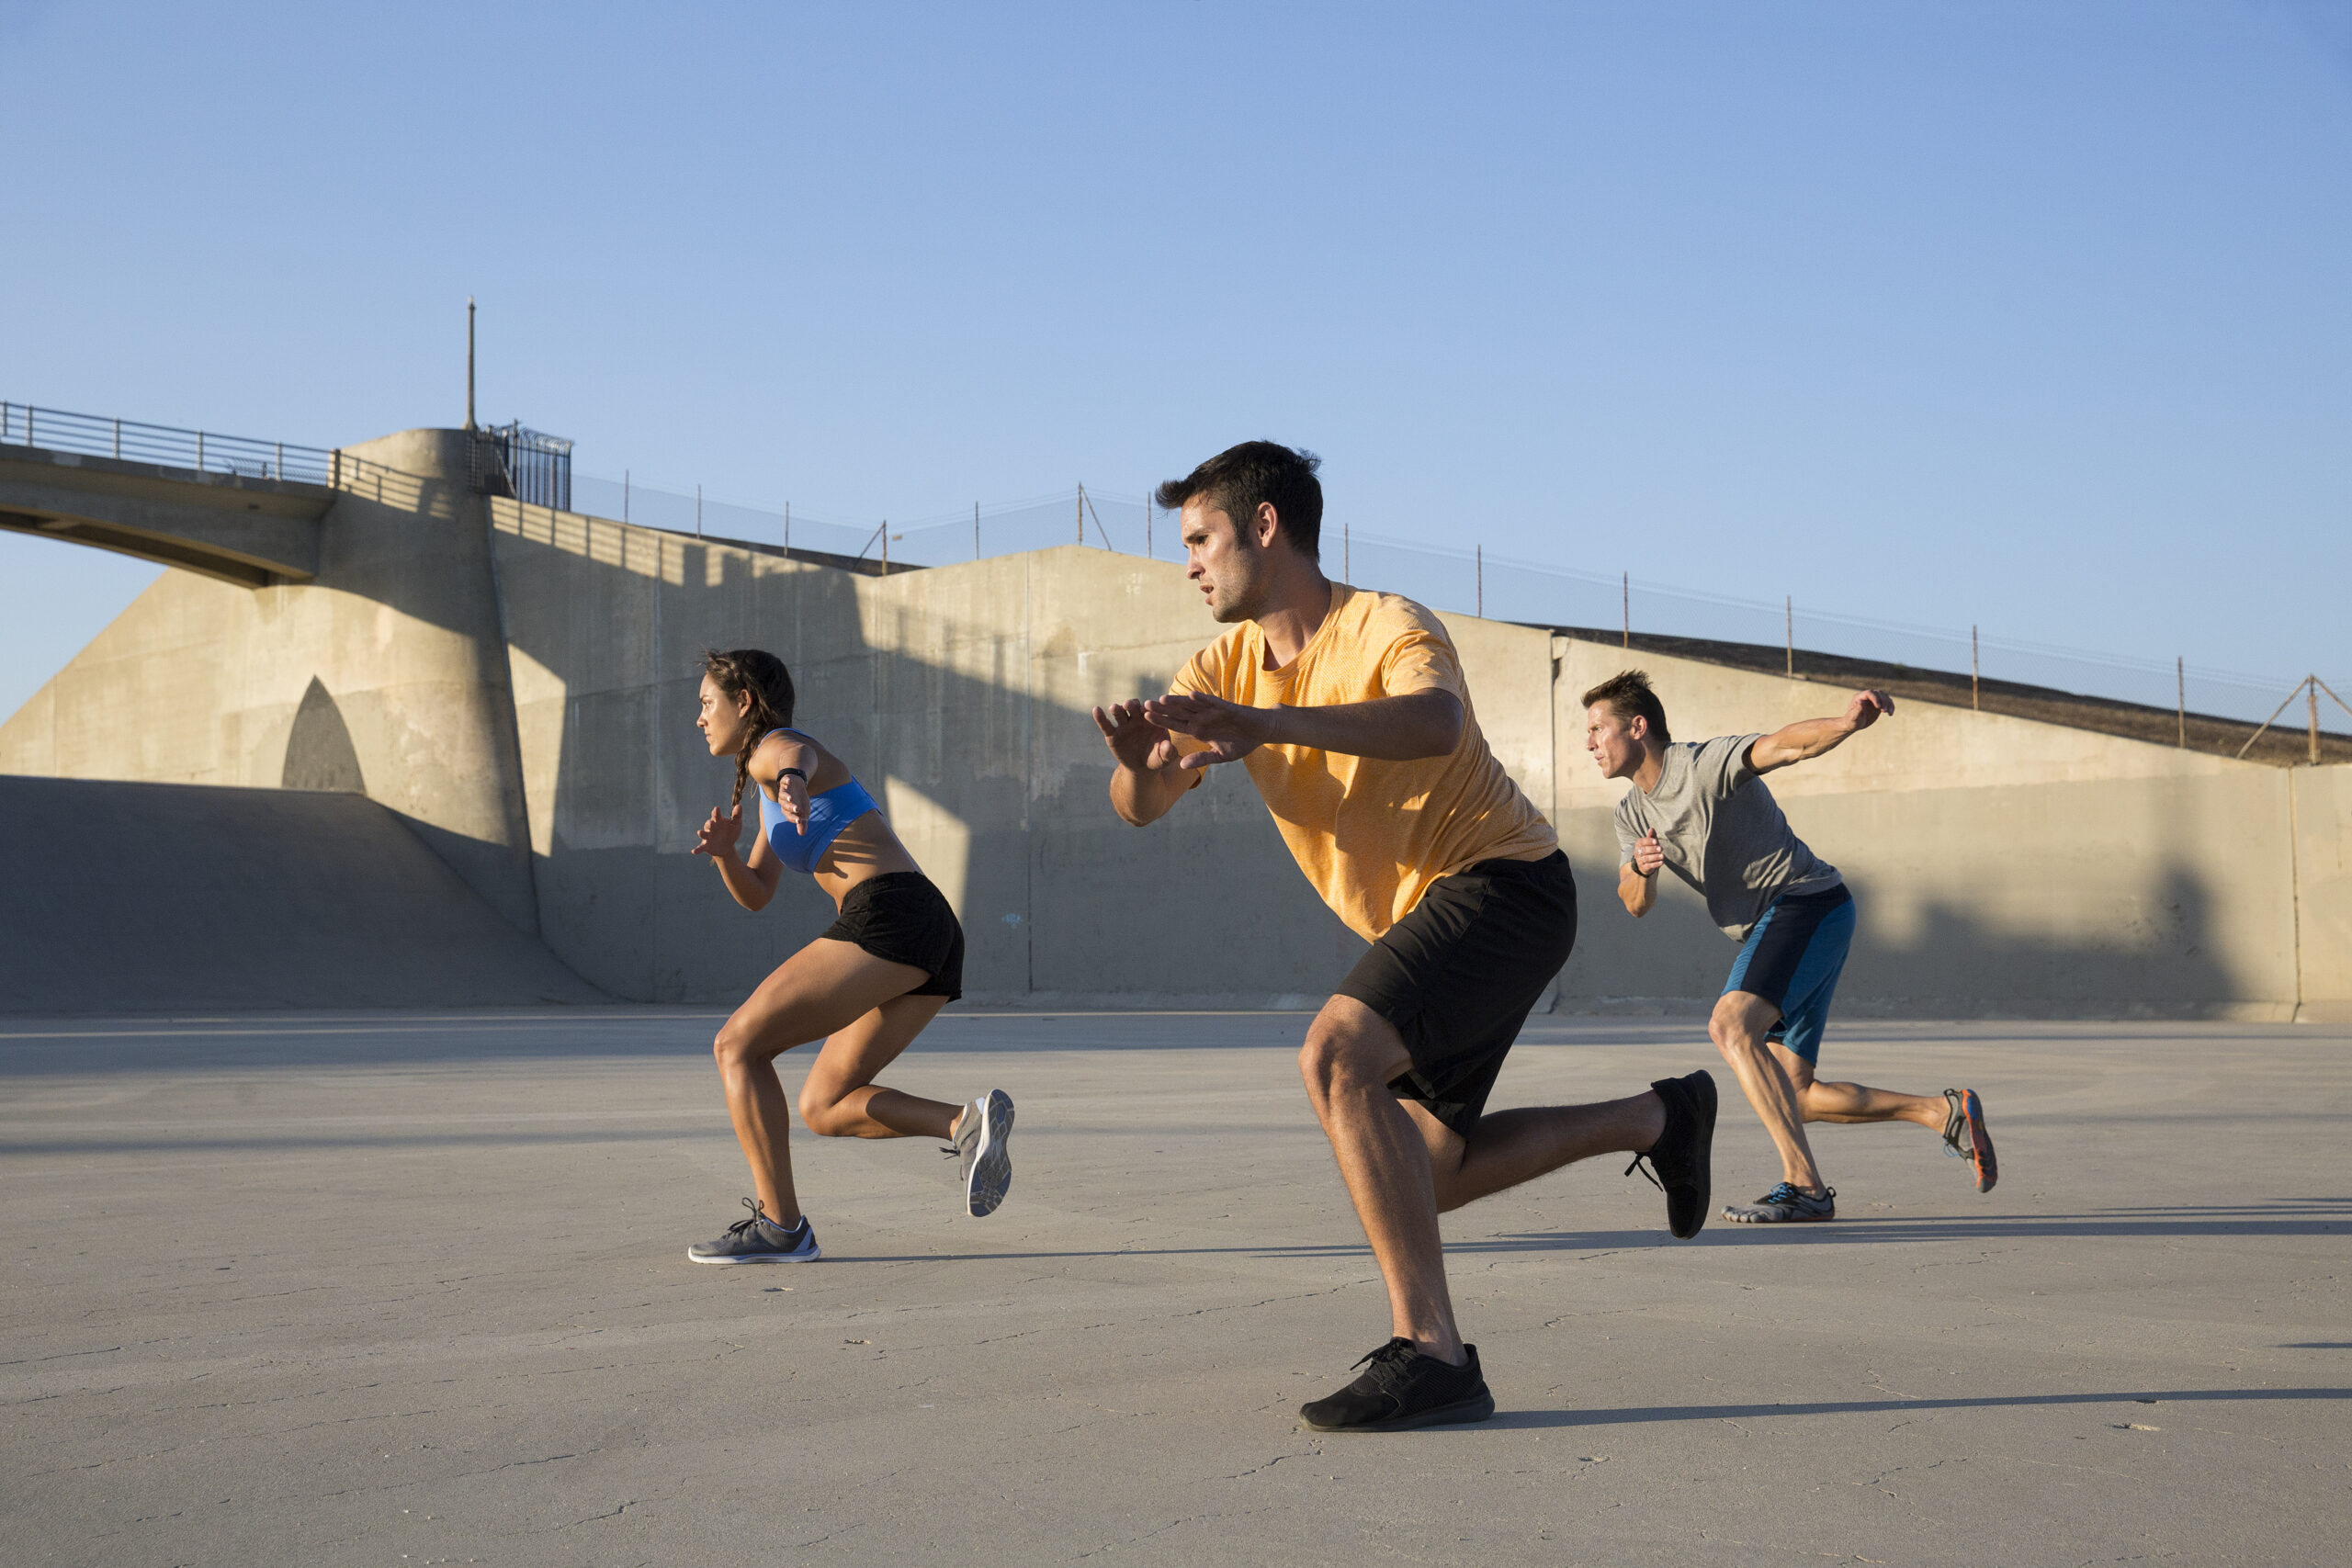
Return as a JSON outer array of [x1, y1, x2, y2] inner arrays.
[[687, 649, 1013, 1262]]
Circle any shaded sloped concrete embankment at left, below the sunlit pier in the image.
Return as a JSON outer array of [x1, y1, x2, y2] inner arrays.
[[0, 776, 605, 1013]]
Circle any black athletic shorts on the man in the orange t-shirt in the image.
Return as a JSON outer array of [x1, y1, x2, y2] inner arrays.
[[1339, 851, 1576, 1138]]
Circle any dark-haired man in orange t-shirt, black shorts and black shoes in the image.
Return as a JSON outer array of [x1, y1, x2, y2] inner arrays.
[[1093, 442, 1714, 1432]]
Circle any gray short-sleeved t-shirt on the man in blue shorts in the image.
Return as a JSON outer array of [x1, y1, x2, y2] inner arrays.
[[1616, 736, 1844, 942]]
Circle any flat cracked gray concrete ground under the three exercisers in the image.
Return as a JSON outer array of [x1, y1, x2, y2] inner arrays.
[[0, 1009, 2352, 1568]]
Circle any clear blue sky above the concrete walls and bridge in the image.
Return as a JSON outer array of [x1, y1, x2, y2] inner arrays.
[[0, 0, 2352, 712]]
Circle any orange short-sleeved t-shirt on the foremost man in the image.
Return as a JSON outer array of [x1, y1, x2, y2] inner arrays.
[[1176, 583, 1559, 941]]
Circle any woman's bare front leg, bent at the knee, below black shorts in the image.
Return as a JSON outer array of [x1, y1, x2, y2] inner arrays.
[[710, 938, 953, 1224]]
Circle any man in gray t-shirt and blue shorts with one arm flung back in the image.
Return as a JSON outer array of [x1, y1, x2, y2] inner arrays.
[[1585, 670, 1996, 1224]]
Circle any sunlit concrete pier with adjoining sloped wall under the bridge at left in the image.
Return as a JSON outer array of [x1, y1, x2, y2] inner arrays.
[[0, 430, 538, 931]]
